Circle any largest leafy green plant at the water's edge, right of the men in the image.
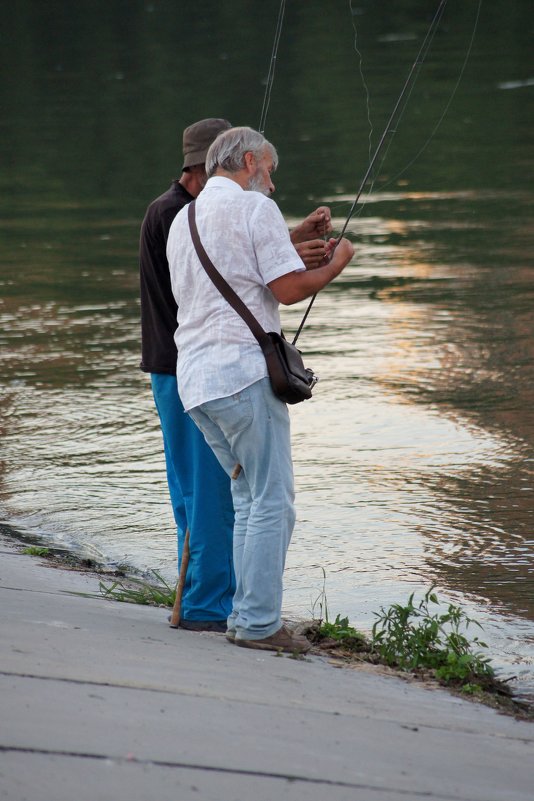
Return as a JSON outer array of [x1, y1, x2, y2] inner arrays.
[[371, 587, 494, 688]]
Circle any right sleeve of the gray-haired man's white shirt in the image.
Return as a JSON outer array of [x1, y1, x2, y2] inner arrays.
[[250, 197, 306, 284]]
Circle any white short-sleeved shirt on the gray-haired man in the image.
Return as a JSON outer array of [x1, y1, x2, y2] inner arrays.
[[167, 176, 305, 411]]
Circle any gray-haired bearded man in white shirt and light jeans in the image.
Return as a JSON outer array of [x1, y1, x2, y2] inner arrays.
[[167, 128, 354, 652]]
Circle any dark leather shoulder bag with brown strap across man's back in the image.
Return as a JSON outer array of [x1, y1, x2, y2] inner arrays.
[[187, 200, 318, 403]]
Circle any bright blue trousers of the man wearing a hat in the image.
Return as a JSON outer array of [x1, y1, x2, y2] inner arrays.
[[150, 373, 235, 620]]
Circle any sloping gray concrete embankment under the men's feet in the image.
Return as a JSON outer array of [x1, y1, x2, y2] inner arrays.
[[0, 536, 534, 801]]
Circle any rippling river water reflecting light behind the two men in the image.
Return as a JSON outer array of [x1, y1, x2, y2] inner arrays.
[[0, 0, 534, 694]]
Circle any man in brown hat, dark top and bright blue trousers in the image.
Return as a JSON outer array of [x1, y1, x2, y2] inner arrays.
[[139, 118, 338, 632]]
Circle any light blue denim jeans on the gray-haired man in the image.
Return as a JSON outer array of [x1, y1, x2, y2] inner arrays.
[[189, 378, 295, 640]]
